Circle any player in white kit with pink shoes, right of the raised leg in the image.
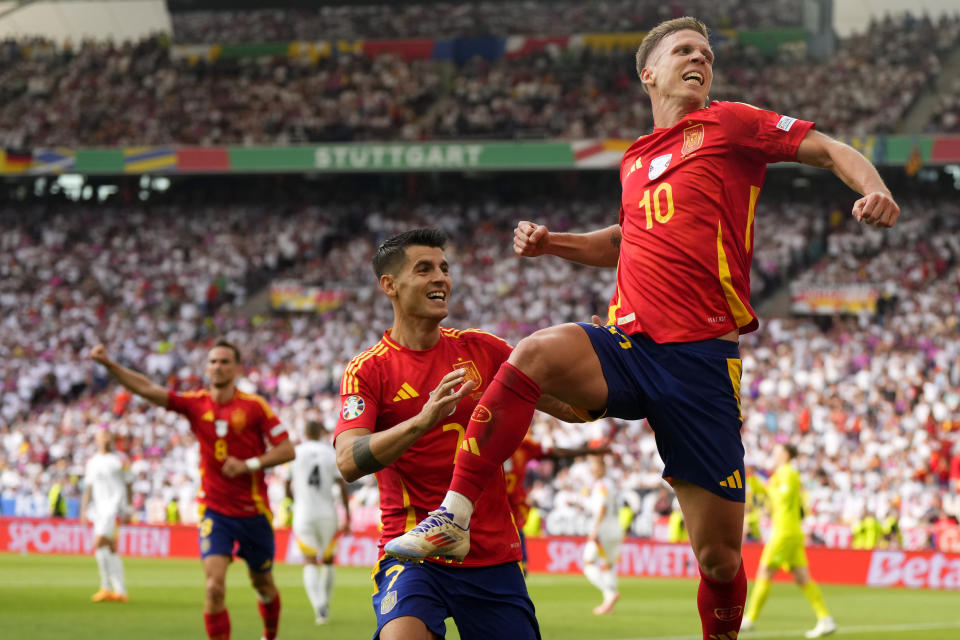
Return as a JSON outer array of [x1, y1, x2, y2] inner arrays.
[[583, 456, 623, 615]]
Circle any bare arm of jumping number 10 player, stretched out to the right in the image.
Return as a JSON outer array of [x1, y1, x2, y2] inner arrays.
[[797, 129, 900, 227]]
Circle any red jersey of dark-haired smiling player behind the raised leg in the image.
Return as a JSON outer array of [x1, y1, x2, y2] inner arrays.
[[334, 328, 520, 566]]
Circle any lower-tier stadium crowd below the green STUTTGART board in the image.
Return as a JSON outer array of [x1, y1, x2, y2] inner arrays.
[[0, 179, 960, 552]]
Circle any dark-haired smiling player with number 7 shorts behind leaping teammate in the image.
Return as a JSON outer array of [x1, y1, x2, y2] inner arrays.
[[334, 229, 579, 640]]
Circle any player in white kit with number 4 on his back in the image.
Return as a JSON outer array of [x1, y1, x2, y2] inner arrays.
[[290, 421, 350, 624]]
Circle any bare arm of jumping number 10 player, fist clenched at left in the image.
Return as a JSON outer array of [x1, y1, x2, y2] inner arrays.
[[513, 220, 622, 267]]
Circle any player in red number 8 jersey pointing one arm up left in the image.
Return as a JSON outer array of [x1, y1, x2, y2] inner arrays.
[[90, 340, 294, 640]]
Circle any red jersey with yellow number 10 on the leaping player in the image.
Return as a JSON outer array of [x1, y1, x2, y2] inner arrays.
[[608, 102, 813, 343]]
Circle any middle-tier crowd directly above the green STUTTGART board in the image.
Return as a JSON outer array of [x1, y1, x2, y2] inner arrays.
[[0, 12, 960, 149]]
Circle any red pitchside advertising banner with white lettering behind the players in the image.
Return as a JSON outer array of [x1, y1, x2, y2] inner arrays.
[[0, 518, 960, 591]]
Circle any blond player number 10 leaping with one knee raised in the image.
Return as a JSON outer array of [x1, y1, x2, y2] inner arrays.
[[386, 17, 900, 638]]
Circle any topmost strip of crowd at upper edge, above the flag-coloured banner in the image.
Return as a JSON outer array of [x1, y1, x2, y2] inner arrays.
[[172, 0, 803, 44]]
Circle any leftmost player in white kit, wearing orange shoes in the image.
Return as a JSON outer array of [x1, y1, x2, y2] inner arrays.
[[80, 428, 130, 602]]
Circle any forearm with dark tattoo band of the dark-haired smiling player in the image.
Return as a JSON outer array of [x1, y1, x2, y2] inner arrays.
[[334, 369, 476, 482]]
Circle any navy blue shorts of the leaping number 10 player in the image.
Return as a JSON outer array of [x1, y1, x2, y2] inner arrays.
[[578, 322, 746, 502]]
